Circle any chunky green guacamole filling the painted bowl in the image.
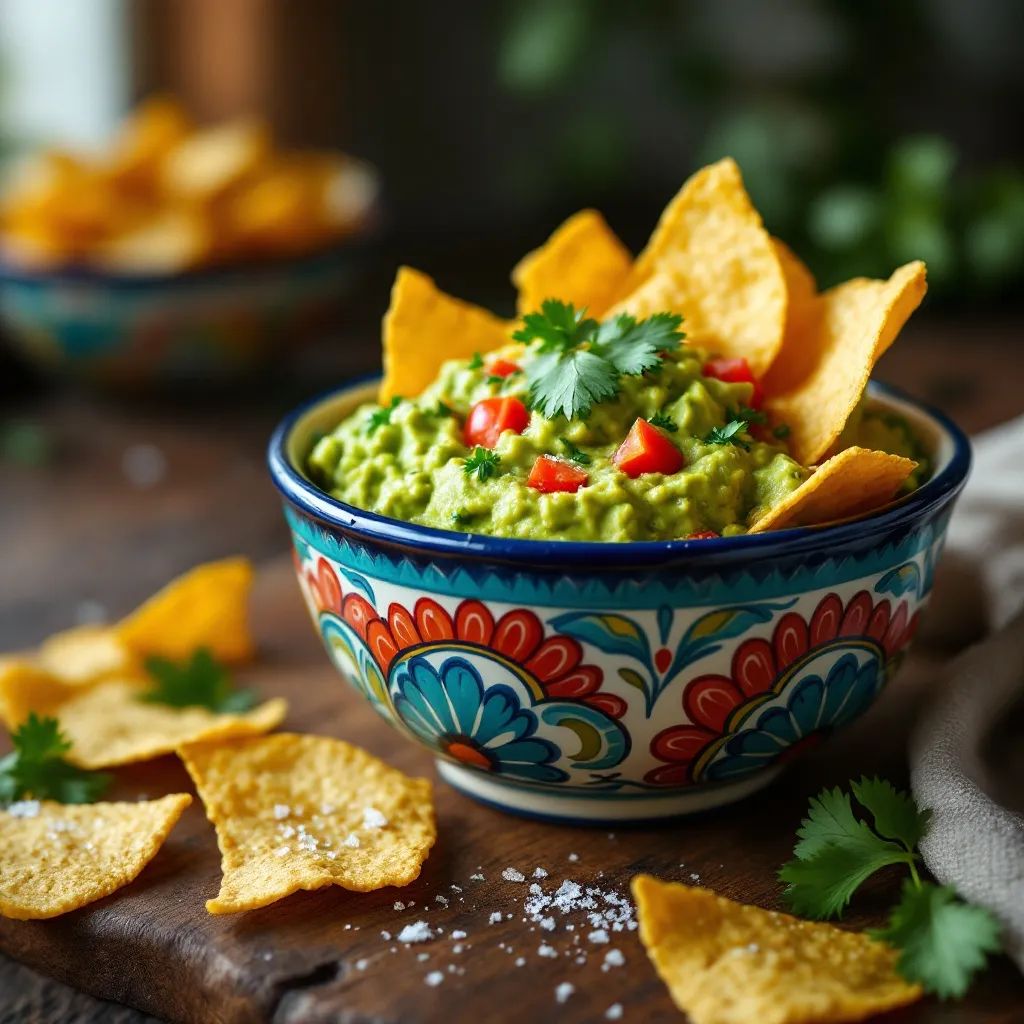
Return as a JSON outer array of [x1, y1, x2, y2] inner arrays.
[[307, 335, 925, 542]]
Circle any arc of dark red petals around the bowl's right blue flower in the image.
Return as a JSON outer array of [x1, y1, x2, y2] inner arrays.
[[645, 590, 918, 785]]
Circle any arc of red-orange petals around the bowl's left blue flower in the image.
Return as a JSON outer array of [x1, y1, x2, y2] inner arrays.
[[305, 558, 626, 718]]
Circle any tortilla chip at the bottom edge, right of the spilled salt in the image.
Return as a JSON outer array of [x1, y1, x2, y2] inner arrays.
[[633, 874, 922, 1024]]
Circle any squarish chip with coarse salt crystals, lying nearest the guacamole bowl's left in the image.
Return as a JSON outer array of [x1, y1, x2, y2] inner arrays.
[[181, 733, 436, 913]]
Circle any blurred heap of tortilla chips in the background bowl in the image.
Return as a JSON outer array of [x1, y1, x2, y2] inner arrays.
[[0, 97, 377, 273]]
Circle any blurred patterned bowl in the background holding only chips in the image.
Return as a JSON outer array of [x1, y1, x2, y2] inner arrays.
[[0, 244, 356, 387]]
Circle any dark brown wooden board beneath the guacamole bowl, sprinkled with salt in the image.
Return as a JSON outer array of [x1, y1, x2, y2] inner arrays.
[[0, 560, 1024, 1024]]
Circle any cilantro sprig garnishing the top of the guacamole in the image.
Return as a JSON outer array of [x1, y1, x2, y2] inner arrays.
[[512, 299, 683, 420]]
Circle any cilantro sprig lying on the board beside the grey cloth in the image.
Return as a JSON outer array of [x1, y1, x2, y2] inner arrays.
[[779, 778, 1000, 998]]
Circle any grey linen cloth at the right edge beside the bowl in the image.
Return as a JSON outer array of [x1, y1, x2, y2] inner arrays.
[[909, 417, 1024, 971]]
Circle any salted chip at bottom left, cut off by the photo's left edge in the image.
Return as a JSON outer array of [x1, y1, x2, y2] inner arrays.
[[0, 793, 191, 921]]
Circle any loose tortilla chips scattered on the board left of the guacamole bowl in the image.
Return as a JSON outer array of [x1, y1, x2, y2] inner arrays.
[[0, 558, 436, 920]]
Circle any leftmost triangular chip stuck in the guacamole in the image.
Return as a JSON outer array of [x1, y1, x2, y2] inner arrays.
[[380, 266, 509, 401]]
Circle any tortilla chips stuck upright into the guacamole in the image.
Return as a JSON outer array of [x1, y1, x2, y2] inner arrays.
[[381, 160, 926, 532]]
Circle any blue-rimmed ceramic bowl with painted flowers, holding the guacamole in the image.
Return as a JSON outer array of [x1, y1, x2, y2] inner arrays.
[[269, 382, 971, 823]]
